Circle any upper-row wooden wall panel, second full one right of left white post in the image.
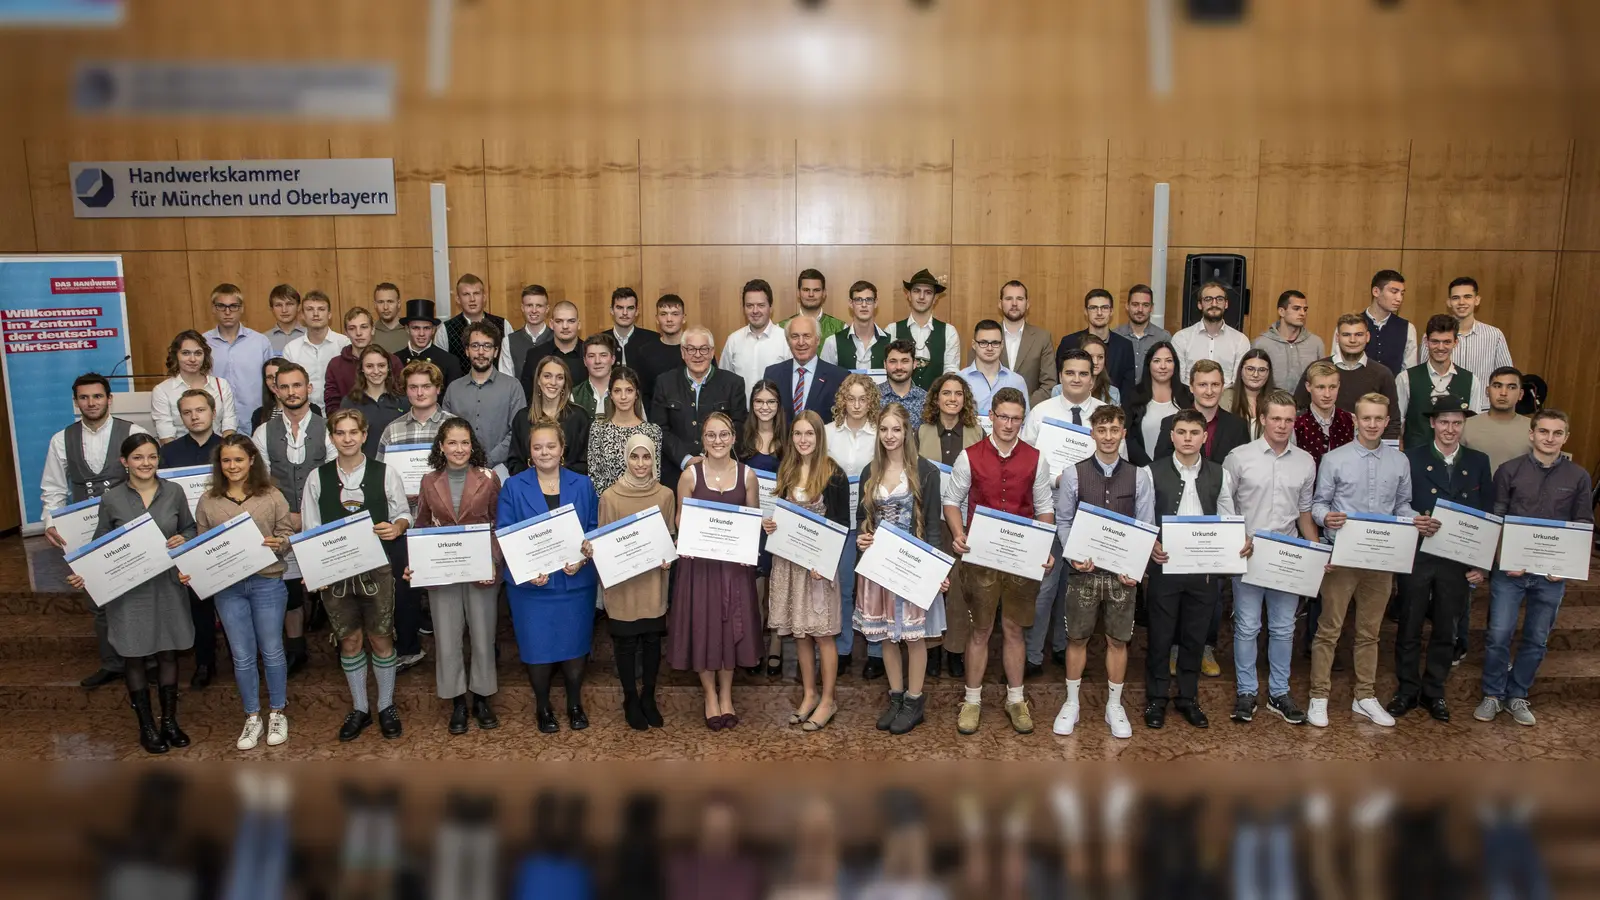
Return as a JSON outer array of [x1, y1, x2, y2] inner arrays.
[[638, 138, 795, 243]]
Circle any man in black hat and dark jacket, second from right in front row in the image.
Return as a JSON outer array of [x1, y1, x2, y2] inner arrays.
[[1387, 395, 1494, 722]]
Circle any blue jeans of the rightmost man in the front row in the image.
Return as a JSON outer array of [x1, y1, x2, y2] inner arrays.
[[1483, 572, 1566, 700]]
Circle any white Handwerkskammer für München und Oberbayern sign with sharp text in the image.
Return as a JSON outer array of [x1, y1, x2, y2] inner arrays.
[[69, 159, 395, 219]]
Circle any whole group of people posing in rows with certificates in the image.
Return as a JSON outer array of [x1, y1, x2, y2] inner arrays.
[[42, 269, 1592, 753]]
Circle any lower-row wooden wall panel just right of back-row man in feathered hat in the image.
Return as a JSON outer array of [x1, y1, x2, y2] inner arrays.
[[940, 247, 1122, 341]]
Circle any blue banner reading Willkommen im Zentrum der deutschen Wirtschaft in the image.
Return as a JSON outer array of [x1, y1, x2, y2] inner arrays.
[[0, 256, 130, 527]]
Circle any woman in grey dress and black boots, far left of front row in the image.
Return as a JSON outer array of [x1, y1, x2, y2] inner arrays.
[[67, 434, 195, 753]]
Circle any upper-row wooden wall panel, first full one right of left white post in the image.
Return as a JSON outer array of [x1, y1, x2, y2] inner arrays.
[[483, 139, 638, 247]]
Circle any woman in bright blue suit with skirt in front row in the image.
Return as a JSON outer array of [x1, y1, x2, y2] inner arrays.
[[494, 418, 600, 733]]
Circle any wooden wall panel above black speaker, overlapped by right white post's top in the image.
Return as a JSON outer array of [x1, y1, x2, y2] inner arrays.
[[1106, 139, 1261, 250]]
